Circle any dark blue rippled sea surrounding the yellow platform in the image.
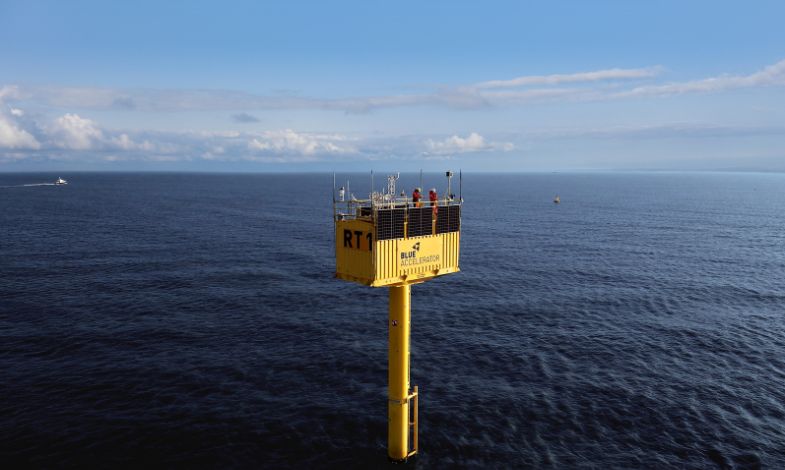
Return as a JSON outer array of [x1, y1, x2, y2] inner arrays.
[[0, 173, 785, 469]]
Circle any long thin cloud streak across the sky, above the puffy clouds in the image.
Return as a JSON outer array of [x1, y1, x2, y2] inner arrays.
[[0, 60, 785, 114]]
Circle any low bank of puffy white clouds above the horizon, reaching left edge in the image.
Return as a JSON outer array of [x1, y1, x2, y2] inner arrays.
[[0, 102, 496, 162]]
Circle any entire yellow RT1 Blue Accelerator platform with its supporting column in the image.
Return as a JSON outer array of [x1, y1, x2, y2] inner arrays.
[[333, 171, 463, 461]]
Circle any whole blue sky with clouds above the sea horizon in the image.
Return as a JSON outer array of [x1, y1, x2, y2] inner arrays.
[[0, 0, 785, 171]]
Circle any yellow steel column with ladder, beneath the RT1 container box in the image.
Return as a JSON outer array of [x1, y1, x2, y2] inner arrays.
[[387, 284, 411, 460]]
